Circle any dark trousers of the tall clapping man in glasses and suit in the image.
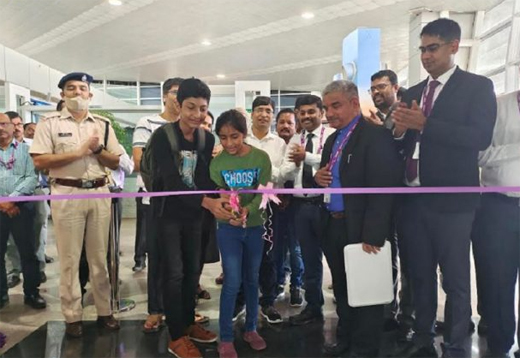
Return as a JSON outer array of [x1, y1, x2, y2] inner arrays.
[[401, 195, 475, 357]]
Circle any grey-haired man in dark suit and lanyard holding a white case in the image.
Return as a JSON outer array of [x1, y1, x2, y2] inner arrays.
[[315, 81, 402, 357]]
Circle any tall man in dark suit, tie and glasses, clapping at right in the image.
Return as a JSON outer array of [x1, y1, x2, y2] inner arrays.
[[393, 19, 496, 357]]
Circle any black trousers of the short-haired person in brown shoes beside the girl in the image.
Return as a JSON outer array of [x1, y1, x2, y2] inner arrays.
[[157, 217, 201, 340]]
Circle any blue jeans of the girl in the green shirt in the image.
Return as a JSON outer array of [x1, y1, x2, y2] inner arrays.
[[217, 223, 264, 342]]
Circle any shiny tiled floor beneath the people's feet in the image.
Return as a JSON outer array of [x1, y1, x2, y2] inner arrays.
[[0, 219, 516, 358]]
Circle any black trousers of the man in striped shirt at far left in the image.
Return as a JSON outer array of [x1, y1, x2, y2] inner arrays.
[[0, 202, 40, 297]]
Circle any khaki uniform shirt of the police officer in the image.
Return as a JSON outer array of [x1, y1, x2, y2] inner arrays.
[[30, 108, 123, 180]]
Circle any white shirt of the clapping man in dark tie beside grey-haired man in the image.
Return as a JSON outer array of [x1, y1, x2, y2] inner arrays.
[[281, 125, 336, 198]]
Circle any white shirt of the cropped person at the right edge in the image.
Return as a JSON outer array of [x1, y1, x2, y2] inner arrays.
[[479, 91, 520, 198]]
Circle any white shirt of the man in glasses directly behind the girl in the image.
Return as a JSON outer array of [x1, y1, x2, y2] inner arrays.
[[246, 128, 287, 188]]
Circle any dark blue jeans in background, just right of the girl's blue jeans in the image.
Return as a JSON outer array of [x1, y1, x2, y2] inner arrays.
[[273, 203, 303, 287]]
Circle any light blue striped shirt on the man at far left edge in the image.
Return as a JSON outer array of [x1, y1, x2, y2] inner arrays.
[[0, 138, 38, 197]]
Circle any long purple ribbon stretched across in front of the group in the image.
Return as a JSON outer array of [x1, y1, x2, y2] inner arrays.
[[0, 186, 520, 203]]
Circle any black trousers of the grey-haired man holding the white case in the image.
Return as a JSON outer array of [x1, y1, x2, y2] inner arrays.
[[322, 214, 384, 357]]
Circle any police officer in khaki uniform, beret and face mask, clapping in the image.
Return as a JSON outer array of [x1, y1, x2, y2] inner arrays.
[[30, 72, 123, 337]]
